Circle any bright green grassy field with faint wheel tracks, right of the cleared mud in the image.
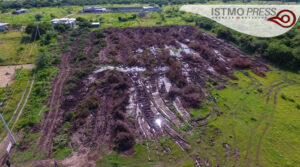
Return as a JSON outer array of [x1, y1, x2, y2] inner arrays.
[[205, 69, 300, 166]]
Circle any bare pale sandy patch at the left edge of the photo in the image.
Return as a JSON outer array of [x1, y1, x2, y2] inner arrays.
[[0, 64, 33, 88]]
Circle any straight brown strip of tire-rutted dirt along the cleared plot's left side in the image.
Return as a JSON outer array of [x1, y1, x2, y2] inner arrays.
[[38, 54, 71, 153]]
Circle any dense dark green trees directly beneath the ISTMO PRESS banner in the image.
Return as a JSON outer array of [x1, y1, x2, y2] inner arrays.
[[196, 18, 300, 70]]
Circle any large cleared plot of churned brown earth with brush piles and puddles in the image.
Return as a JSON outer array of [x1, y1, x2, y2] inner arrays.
[[40, 26, 267, 160]]
